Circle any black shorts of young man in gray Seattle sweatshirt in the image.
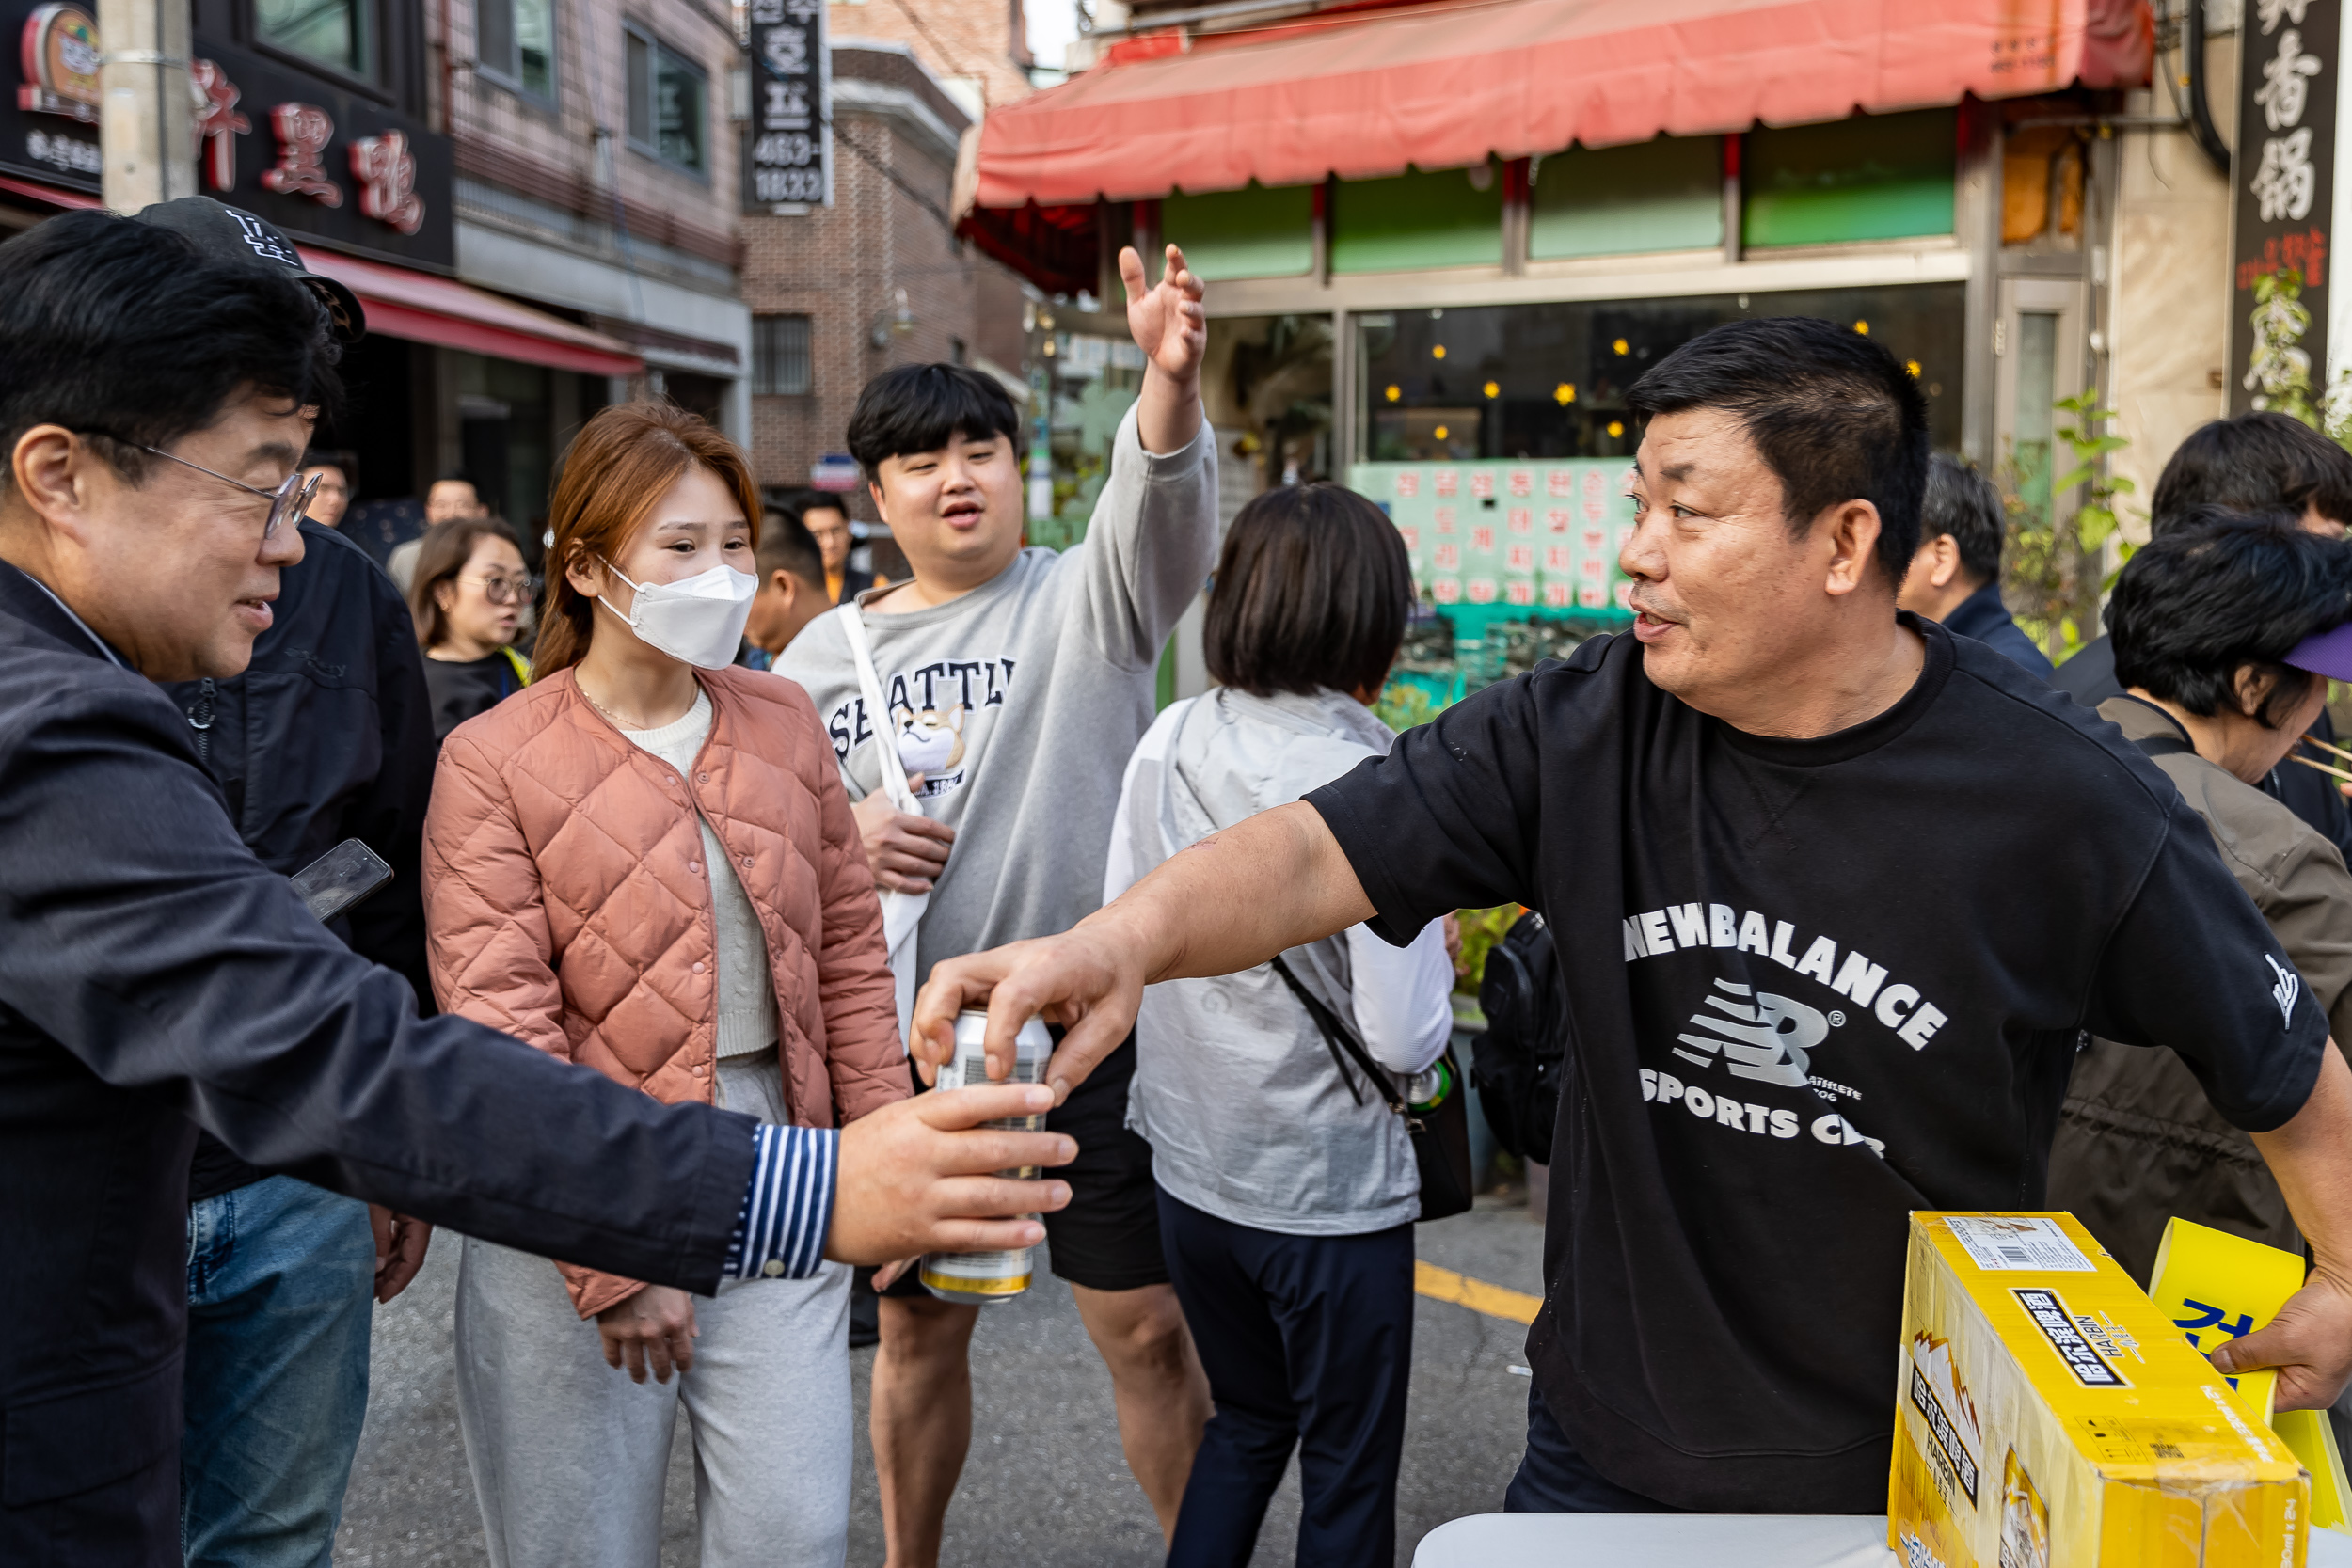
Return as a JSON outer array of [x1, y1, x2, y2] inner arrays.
[[882, 1043, 1169, 1298]]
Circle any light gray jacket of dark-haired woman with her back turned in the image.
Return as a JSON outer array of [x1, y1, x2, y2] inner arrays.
[[1104, 689, 1461, 1237]]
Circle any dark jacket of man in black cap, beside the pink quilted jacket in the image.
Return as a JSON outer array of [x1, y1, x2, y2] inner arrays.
[[165, 519, 436, 1199]]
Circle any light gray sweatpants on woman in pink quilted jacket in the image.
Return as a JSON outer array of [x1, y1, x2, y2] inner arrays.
[[456, 1055, 851, 1568]]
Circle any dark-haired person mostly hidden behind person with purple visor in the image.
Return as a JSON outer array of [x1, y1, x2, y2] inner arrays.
[[2051, 411, 2352, 856]]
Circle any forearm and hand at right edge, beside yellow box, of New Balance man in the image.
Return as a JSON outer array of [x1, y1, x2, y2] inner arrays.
[[2214, 1044, 2352, 1411]]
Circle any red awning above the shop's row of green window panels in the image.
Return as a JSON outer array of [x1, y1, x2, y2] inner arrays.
[[974, 0, 2153, 209]]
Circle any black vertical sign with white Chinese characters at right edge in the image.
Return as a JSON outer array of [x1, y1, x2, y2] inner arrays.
[[2230, 0, 2343, 414]]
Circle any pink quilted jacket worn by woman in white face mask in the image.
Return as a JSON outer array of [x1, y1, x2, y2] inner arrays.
[[423, 670, 908, 1317]]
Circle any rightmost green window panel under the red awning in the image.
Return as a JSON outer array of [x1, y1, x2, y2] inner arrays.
[[1740, 108, 1960, 246]]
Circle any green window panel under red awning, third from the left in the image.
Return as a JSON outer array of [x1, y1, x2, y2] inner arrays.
[[1527, 136, 1724, 261]]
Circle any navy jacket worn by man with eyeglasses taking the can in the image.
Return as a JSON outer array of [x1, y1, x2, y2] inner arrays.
[[0, 564, 755, 1542]]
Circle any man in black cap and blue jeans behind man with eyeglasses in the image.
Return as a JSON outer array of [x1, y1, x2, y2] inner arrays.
[[114, 198, 436, 1568]]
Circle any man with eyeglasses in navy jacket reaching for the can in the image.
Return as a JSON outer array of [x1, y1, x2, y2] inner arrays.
[[0, 198, 1071, 1568]]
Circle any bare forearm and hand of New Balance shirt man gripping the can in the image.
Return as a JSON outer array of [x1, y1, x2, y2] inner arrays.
[[911, 801, 1374, 1098]]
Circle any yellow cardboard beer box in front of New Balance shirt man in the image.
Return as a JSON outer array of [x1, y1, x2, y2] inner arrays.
[[1886, 1213, 2310, 1568]]
